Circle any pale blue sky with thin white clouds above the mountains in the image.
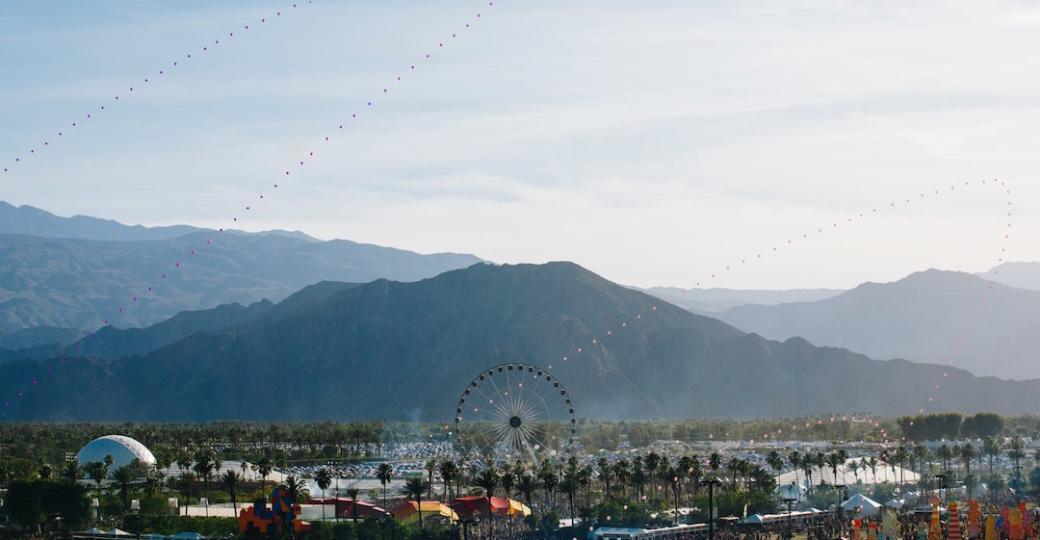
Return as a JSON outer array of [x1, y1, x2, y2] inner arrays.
[[0, 0, 1040, 288]]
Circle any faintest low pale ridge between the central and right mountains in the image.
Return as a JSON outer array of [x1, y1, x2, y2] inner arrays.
[[643, 287, 843, 314]]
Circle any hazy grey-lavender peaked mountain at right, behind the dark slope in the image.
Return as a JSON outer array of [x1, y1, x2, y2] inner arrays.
[[719, 269, 1040, 379]]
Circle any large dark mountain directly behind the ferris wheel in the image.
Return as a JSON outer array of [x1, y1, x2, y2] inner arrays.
[[0, 263, 1040, 420]]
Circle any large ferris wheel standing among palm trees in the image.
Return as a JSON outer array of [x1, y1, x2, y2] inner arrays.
[[454, 363, 577, 461]]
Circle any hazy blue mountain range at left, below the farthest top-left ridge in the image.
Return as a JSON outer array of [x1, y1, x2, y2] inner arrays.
[[0, 232, 479, 335]]
